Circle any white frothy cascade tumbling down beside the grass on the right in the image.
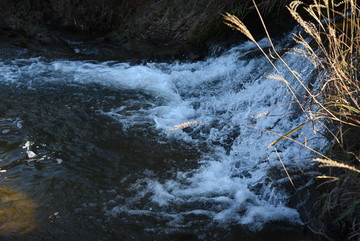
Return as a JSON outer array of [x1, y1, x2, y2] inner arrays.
[[110, 39, 326, 229]]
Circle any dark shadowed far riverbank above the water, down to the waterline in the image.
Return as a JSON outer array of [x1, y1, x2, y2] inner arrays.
[[0, 0, 294, 61]]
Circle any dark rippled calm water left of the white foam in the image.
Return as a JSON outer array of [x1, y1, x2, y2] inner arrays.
[[0, 84, 208, 240]]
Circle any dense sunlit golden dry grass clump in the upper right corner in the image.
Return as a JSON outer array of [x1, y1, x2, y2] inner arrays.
[[288, 0, 360, 127]]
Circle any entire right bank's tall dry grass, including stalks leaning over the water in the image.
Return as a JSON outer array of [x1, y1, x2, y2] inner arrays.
[[224, 0, 360, 240]]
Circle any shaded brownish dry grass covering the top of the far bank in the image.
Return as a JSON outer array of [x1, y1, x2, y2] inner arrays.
[[0, 0, 296, 45]]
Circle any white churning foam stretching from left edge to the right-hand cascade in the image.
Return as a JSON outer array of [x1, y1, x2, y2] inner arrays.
[[0, 35, 326, 229]]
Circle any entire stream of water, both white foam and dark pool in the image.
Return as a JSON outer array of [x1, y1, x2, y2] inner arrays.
[[0, 34, 326, 240]]
